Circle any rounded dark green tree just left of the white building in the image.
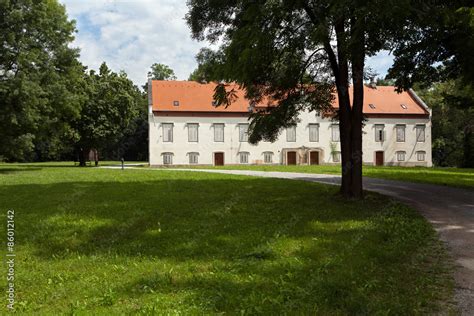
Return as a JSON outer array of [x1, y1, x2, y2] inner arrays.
[[74, 63, 143, 166]]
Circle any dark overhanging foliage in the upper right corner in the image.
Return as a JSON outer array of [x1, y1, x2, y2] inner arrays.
[[388, 0, 474, 88]]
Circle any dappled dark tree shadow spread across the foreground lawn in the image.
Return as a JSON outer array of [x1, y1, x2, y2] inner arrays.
[[0, 174, 452, 314]]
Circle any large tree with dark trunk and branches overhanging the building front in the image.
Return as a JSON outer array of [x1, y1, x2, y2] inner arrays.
[[187, 0, 462, 198]]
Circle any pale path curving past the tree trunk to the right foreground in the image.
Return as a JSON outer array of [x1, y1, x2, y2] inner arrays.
[[106, 169, 474, 315]]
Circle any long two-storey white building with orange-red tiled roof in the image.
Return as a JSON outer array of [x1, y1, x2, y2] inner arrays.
[[148, 80, 432, 167]]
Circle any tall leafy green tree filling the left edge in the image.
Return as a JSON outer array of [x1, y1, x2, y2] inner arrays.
[[0, 0, 83, 161]]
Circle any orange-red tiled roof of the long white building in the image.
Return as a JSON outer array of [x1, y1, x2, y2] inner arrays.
[[152, 80, 428, 115]]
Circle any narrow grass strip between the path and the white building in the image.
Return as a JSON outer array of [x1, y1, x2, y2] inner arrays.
[[184, 165, 474, 189]]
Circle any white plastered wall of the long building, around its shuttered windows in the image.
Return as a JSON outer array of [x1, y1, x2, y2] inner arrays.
[[149, 112, 432, 166]]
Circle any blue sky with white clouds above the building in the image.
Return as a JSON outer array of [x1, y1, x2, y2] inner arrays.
[[60, 0, 392, 86]]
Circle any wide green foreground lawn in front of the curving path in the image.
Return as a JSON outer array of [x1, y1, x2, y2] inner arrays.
[[0, 164, 452, 315]]
